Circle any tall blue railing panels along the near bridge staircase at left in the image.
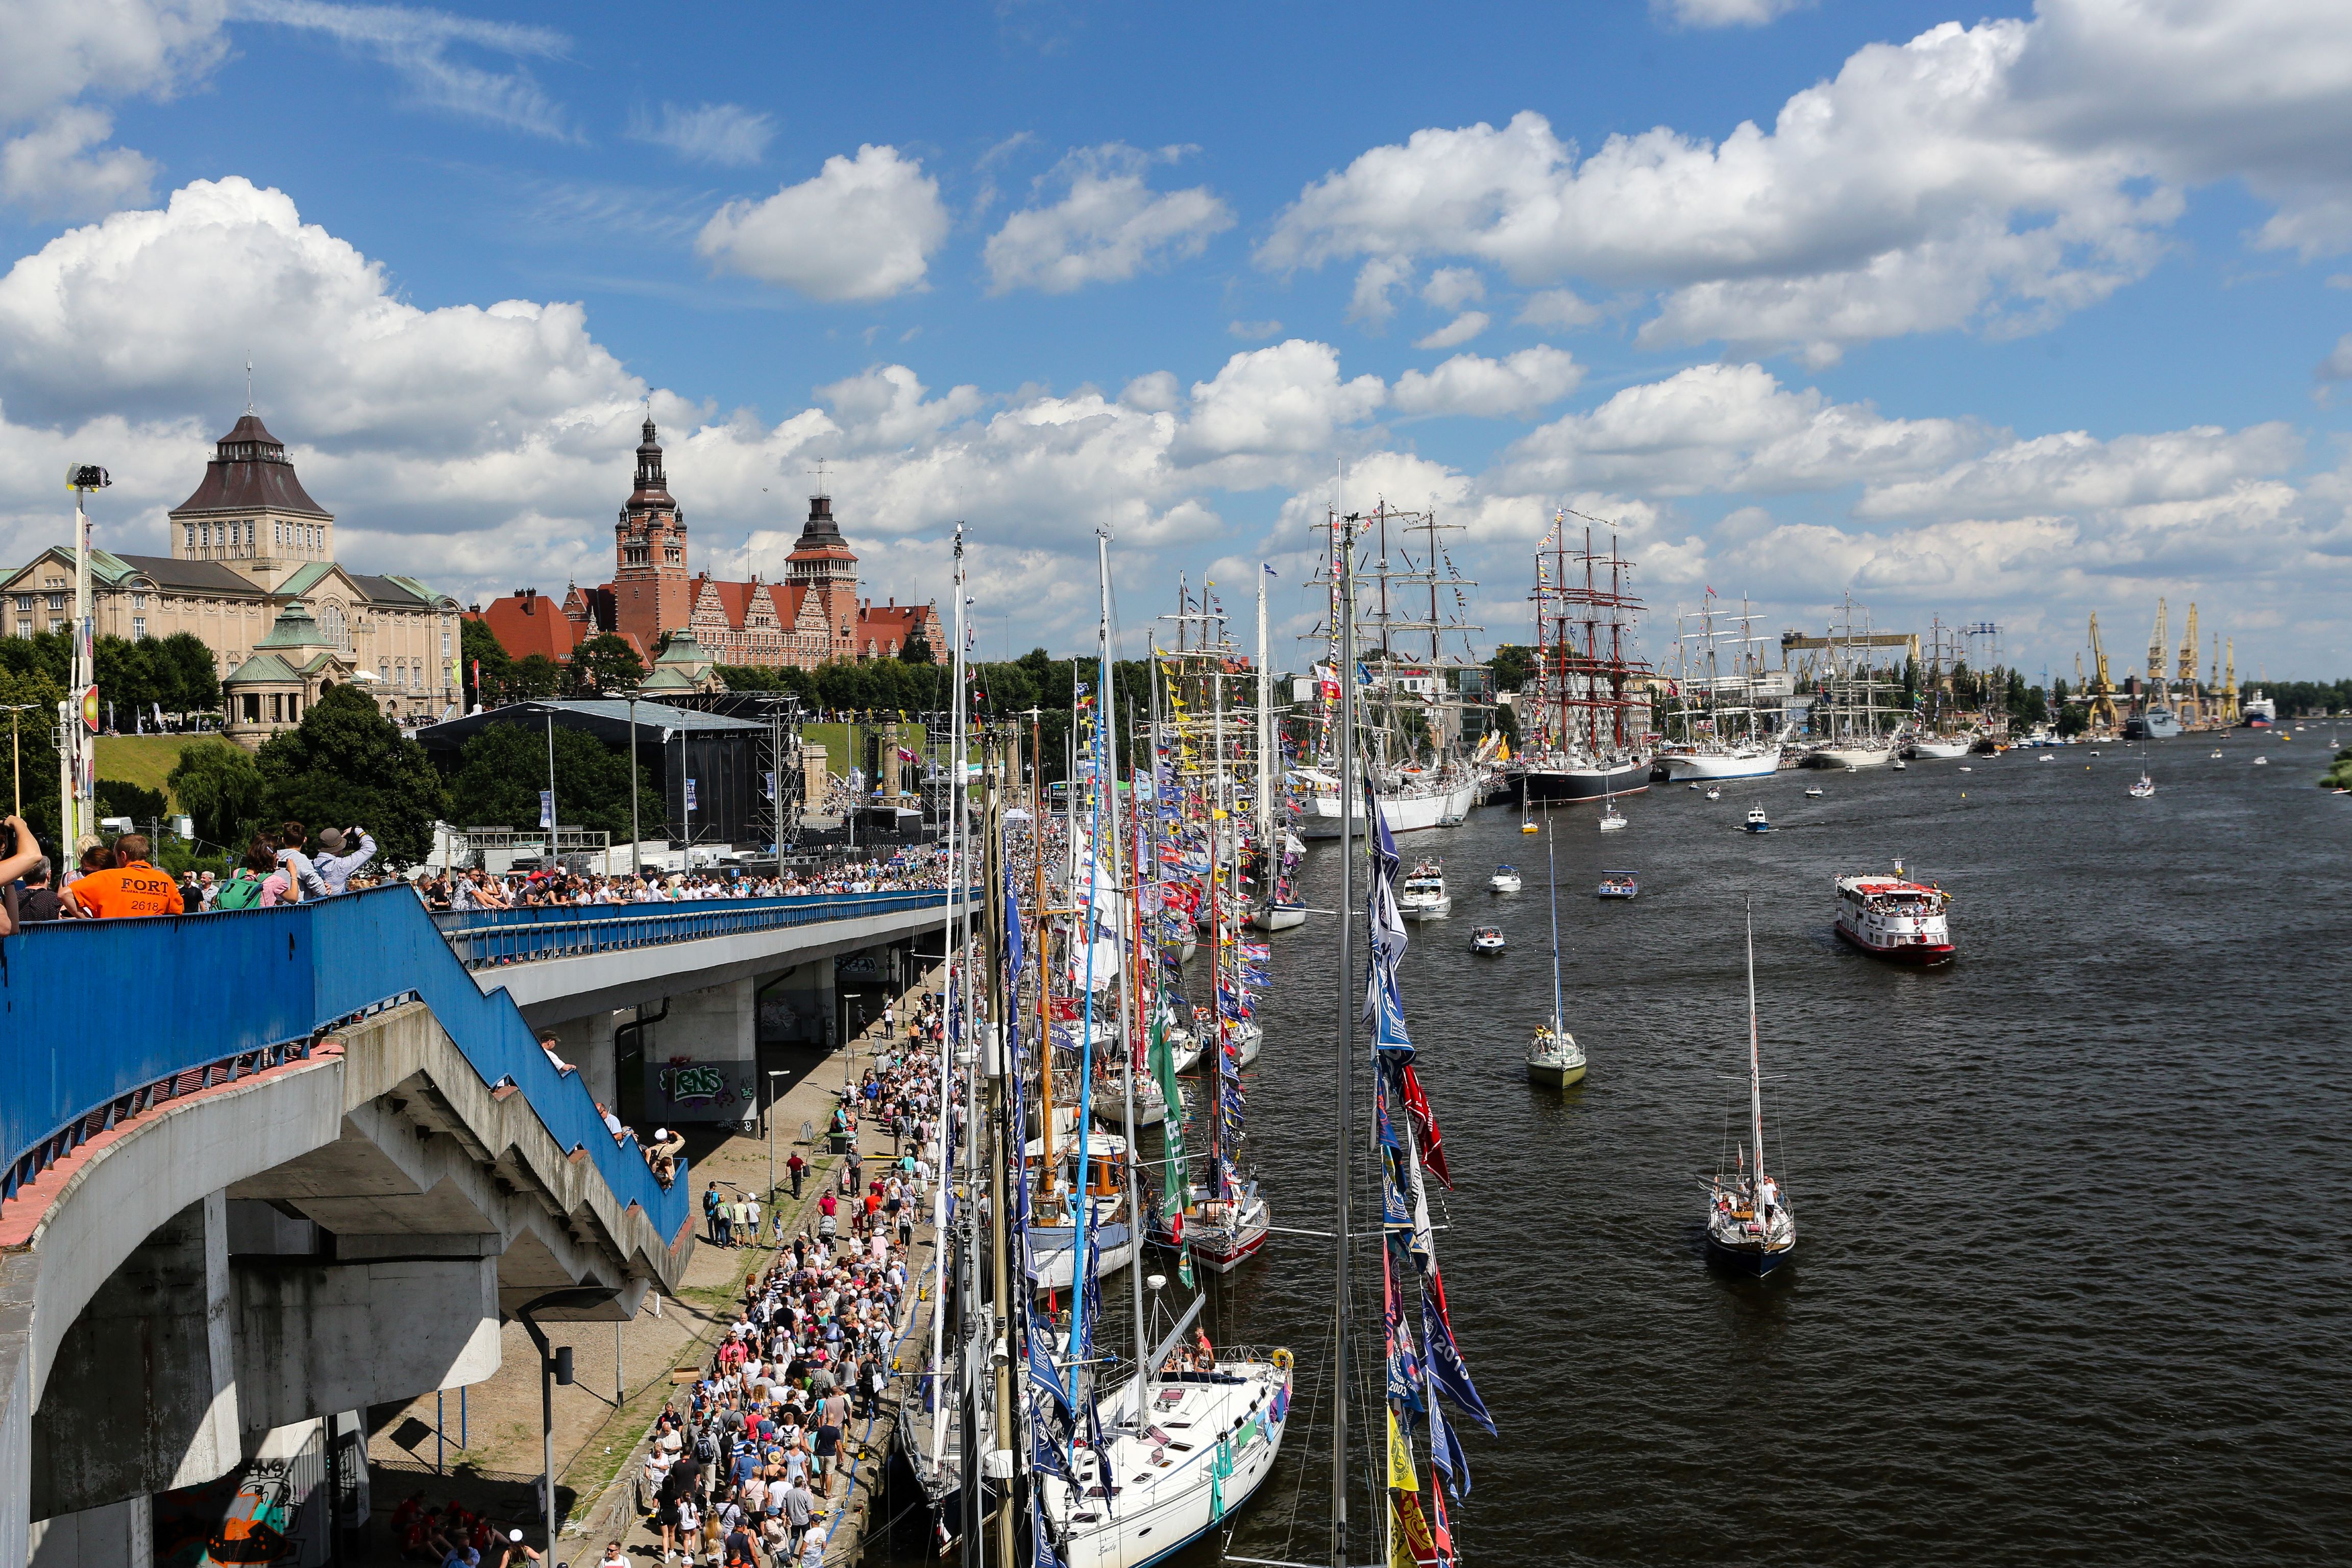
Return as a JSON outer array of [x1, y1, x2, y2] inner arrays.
[[0, 886, 687, 1237]]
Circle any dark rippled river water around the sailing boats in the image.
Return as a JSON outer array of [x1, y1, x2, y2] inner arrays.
[[1194, 724, 2352, 1565]]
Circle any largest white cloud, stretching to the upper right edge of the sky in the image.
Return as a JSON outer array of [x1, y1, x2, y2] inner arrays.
[[1258, 0, 2352, 360]]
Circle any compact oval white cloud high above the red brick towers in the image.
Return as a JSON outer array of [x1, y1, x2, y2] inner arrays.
[[694, 143, 948, 303]]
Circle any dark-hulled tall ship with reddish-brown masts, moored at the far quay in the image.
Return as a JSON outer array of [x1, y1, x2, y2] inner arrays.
[[1520, 510, 1651, 806]]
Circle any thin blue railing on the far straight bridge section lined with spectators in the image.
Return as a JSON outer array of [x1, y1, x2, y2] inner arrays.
[[433, 889, 948, 969]]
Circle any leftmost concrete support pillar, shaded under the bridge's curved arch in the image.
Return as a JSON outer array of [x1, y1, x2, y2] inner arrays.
[[31, 1192, 242, 1518]]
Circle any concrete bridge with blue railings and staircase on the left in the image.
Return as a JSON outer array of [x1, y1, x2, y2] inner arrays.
[[0, 889, 964, 1568]]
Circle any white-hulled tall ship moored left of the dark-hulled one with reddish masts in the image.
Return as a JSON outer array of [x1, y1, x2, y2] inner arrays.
[[1291, 501, 1484, 839]]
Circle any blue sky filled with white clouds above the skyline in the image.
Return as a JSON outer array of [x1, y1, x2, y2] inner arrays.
[[0, 0, 2352, 675]]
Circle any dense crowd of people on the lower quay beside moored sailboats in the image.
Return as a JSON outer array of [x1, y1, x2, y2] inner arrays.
[[640, 997, 955, 1568]]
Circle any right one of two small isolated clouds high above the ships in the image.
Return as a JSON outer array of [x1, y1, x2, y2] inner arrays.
[[981, 143, 1233, 294]]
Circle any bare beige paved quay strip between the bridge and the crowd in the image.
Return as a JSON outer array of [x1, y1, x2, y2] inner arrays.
[[369, 971, 941, 1559]]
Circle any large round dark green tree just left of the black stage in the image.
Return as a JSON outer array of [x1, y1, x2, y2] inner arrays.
[[254, 687, 447, 865]]
